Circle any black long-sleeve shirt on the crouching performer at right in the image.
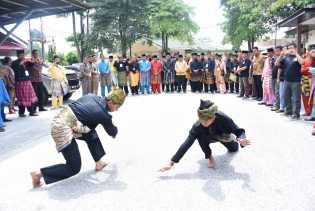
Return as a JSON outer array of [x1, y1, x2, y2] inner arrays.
[[171, 112, 245, 163]]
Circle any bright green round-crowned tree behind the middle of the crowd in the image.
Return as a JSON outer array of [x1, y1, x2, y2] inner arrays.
[[150, 0, 199, 52]]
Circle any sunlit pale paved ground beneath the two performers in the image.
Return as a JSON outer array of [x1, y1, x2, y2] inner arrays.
[[0, 94, 315, 211]]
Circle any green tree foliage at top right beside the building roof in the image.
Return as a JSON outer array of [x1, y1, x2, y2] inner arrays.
[[221, 0, 314, 49]]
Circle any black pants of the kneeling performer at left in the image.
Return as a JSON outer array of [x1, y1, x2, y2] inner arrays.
[[40, 131, 105, 184]]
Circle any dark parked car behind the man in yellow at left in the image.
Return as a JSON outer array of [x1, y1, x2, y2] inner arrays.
[[42, 65, 80, 104]]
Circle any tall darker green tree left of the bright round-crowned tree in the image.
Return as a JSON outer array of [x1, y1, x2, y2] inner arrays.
[[89, 0, 153, 55]]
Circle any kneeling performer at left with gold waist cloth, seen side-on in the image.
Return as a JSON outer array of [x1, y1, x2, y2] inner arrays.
[[31, 89, 126, 188]]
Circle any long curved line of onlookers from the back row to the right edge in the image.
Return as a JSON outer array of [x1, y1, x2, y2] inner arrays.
[[80, 43, 315, 135]]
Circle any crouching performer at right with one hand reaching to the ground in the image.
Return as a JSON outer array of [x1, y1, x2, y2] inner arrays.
[[160, 100, 250, 172]]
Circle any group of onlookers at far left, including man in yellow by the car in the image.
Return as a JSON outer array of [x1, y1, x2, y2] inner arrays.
[[0, 50, 68, 132]]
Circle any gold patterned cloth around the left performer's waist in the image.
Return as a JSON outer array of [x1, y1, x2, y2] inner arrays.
[[51, 106, 91, 152]]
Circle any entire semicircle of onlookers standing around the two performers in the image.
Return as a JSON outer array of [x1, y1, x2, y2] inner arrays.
[[0, 43, 315, 135]]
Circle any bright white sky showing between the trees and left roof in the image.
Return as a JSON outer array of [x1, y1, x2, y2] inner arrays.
[[5, 0, 224, 52]]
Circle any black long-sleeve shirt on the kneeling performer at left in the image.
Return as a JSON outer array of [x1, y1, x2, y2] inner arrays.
[[69, 94, 118, 138]]
